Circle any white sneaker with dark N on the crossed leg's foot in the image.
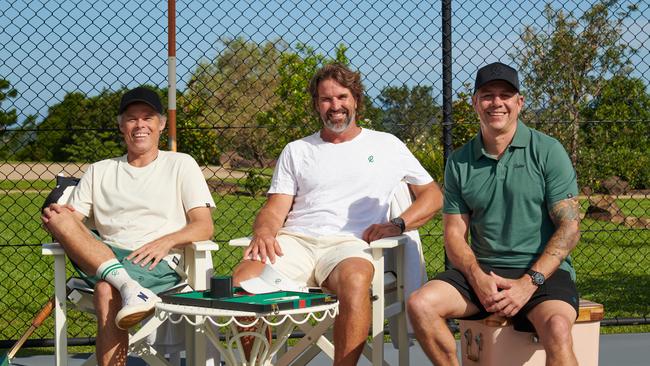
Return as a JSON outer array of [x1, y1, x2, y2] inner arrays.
[[115, 283, 161, 329]]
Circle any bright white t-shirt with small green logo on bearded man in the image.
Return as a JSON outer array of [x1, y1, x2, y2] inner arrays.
[[268, 128, 433, 238]]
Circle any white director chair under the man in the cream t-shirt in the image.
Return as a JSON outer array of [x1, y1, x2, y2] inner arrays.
[[42, 241, 219, 366]]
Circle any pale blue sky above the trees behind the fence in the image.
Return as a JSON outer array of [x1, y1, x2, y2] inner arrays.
[[0, 0, 650, 120]]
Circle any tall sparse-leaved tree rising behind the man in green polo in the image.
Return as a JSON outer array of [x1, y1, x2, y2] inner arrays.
[[511, 0, 637, 165]]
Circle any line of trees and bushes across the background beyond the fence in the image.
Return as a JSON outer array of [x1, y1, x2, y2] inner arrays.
[[0, 0, 650, 189]]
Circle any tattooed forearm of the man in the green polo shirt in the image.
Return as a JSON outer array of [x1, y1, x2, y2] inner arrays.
[[544, 198, 580, 262]]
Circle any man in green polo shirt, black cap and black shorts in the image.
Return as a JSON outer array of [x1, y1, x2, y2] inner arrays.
[[408, 62, 580, 365]]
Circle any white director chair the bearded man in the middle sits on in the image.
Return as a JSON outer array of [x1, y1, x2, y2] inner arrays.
[[230, 182, 426, 366]]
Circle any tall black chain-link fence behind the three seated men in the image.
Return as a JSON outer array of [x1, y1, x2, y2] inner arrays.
[[0, 0, 650, 346]]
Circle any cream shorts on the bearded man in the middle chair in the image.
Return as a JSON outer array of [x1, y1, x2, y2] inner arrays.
[[273, 230, 372, 286]]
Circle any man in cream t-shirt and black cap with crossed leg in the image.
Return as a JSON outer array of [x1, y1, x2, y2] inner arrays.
[[42, 88, 215, 365]]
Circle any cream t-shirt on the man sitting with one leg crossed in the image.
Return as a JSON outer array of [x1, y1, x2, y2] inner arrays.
[[69, 151, 215, 274]]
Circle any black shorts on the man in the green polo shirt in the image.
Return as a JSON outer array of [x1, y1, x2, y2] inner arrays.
[[434, 264, 580, 332]]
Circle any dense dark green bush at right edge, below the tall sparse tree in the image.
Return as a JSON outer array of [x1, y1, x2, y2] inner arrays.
[[577, 76, 650, 190]]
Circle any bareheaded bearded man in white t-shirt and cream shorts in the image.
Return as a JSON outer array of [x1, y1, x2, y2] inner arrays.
[[233, 64, 442, 365]]
